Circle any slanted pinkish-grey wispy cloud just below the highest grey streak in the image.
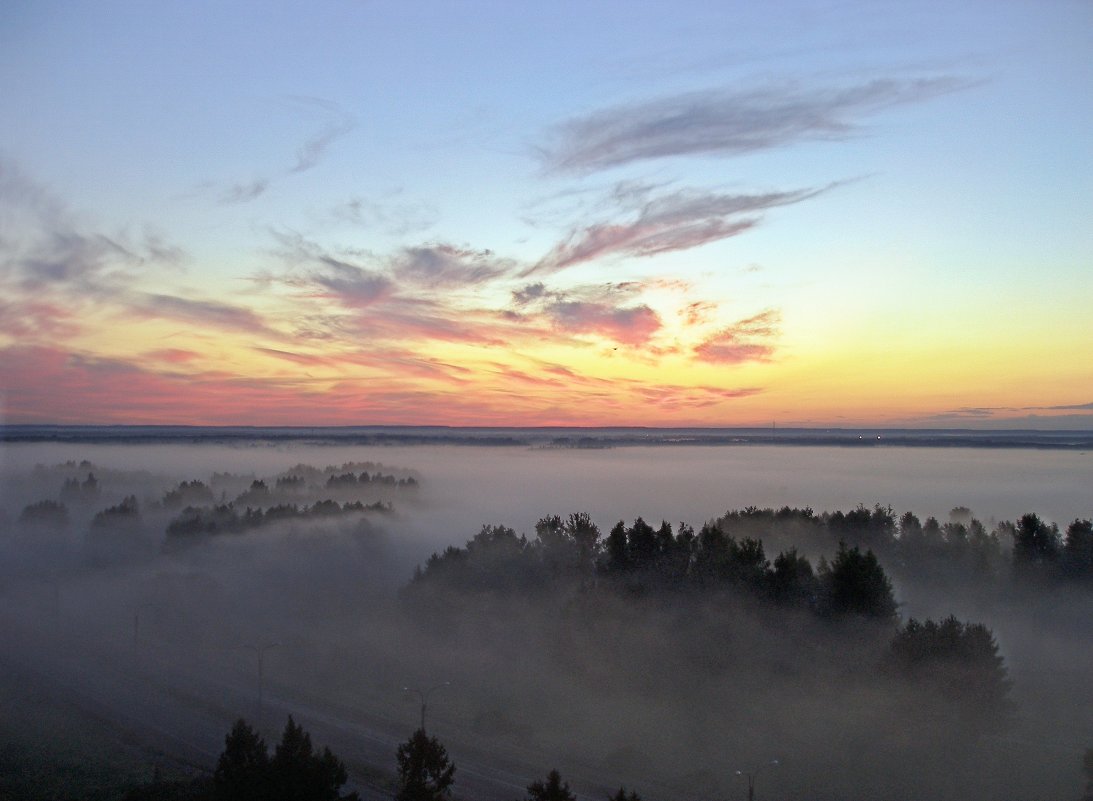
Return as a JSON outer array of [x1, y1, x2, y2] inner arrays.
[[520, 187, 830, 278]]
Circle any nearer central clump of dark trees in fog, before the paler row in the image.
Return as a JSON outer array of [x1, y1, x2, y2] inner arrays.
[[413, 515, 896, 620]]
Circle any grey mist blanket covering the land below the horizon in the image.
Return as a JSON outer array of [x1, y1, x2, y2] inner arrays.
[[0, 441, 1093, 799]]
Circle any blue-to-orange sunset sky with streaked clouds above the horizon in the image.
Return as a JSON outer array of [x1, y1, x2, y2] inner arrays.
[[0, 0, 1093, 428]]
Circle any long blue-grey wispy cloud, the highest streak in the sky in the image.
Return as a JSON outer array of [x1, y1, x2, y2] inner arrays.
[[543, 75, 971, 173]]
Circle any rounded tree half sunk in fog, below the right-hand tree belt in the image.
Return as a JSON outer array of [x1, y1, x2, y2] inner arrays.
[[891, 615, 1013, 721]]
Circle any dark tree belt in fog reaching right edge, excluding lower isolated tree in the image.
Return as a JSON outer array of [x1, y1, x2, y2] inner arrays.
[[414, 506, 1093, 617]]
